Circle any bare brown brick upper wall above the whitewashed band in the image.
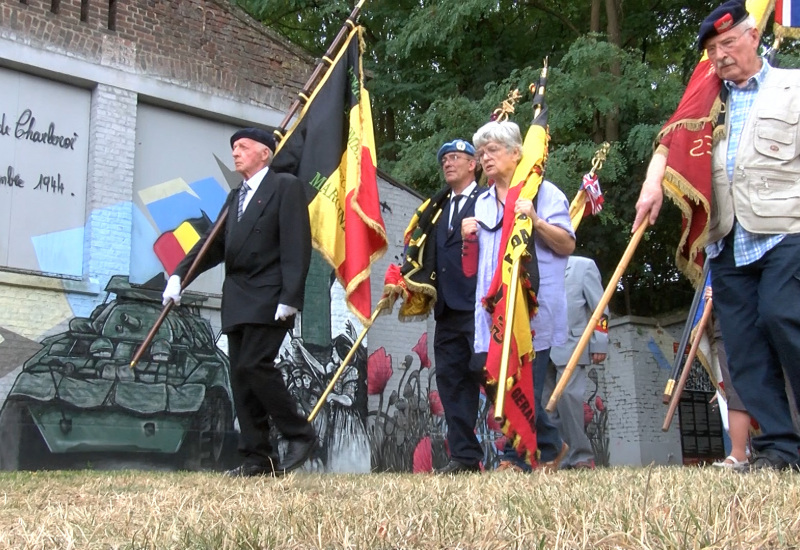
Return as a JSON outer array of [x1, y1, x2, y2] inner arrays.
[[0, 0, 311, 111]]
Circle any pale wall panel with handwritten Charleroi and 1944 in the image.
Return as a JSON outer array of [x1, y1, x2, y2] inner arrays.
[[0, 67, 91, 277]]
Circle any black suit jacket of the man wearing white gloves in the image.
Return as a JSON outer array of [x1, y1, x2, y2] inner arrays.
[[175, 170, 311, 332]]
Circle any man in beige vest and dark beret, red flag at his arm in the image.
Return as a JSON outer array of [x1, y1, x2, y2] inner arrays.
[[634, 0, 800, 470]]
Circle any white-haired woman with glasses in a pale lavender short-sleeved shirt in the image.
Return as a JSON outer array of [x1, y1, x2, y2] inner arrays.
[[461, 121, 575, 470]]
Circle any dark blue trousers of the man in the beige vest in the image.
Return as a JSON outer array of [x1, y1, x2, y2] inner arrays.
[[711, 234, 800, 463]]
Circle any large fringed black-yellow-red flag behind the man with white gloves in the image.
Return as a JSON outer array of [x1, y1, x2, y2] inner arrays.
[[272, 27, 387, 324]]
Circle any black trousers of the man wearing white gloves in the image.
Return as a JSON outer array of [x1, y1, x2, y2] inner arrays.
[[228, 325, 316, 463]]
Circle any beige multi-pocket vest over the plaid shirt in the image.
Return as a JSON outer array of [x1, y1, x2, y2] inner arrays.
[[708, 68, 800, 243]]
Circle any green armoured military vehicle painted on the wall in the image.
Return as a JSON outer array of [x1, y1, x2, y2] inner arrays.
[[0, 276, 234, 469]]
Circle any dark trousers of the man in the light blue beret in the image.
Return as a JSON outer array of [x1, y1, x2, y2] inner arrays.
[[433, 305, 483, 464]]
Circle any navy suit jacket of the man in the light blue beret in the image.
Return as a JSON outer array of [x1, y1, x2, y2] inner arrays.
[[434, 186, 478, 318]]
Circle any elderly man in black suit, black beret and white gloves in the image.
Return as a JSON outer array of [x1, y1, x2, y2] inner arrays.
[[164, 128, 317, 476]]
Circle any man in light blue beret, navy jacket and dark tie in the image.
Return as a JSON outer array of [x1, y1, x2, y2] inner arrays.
[[433, 139, 483, 474]]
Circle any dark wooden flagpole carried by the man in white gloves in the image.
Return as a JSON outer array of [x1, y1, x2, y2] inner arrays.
[[130, 0, 367, 368]]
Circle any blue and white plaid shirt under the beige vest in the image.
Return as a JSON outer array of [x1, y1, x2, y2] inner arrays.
[[706, 59, 785, 266]]
